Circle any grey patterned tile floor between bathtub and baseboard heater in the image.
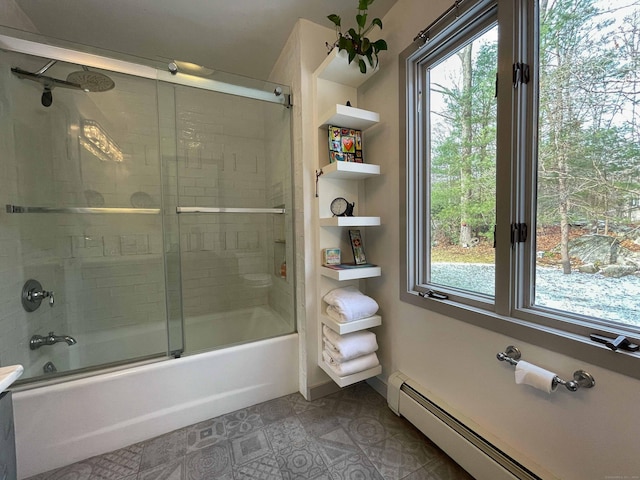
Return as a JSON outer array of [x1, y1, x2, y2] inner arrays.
[[30, 382, 473, 480]]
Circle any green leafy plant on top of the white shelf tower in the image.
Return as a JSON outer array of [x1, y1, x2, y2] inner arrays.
[[327, 0, 387, 73]]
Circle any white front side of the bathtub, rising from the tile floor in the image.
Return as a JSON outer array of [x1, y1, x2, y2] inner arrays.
[[13, 334, 298, 479]]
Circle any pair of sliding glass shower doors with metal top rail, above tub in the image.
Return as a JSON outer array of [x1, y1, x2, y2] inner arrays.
[[0, 27, 295, 383]]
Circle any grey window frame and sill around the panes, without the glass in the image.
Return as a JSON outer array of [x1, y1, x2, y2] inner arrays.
[[399, 0, 640, 379]]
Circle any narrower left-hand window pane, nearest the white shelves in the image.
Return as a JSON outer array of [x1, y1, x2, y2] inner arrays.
[[423, 25, 498, 298]]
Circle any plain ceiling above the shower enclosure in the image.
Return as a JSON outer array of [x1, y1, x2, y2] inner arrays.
[[15, 0, 396, 79]]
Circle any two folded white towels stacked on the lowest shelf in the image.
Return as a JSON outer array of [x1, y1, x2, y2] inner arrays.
[[322, 325, 380, 377]]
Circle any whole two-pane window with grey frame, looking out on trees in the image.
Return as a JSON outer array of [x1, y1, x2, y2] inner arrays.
[[401, 0, 640, 372]]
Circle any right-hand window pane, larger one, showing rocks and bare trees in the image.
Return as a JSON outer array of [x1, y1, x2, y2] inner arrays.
[[531, 0, 640, 326]]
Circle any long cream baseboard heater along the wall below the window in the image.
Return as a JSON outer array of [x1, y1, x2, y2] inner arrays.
[[387, 372, 542, 480]]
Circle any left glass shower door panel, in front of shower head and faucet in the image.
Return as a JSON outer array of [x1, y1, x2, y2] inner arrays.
[[0, 47, 167, 380]]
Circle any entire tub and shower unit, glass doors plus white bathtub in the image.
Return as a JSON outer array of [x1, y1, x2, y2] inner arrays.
[[0, 29, 297, 477]]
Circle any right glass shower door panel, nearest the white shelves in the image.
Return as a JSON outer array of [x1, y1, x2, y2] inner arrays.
[[175, 82, 295, 353]]
